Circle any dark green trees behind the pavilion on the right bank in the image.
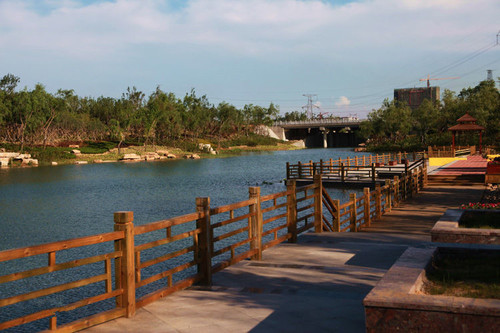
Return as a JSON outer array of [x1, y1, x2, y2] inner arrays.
[[361, 80, 500, 151]]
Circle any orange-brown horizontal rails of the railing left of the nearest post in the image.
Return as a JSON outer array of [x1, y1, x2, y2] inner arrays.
[[0, 231, 126, 330]]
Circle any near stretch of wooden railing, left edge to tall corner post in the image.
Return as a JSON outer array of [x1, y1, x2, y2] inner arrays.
[[0, 184, 321, 331]]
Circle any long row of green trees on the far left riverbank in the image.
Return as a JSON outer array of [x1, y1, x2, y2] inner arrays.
[[0, 74, 290, 149]]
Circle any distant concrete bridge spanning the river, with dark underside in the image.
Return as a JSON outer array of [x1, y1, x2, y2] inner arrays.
[[272, 117, 363, 148]]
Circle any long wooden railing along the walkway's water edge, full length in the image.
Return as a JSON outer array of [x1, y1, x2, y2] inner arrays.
[[0, 166, 426, 332]]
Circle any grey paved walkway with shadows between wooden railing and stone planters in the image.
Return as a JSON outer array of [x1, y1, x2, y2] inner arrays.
[[86, 186, 484, 332]]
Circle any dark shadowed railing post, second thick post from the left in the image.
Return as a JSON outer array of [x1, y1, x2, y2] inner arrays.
[[195, 197, 213, 286]]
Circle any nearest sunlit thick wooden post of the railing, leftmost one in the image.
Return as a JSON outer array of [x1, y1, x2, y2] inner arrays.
[[114, 212, 135, 318]]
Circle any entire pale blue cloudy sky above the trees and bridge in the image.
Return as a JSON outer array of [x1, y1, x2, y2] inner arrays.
[[0, 0, 500, 118]]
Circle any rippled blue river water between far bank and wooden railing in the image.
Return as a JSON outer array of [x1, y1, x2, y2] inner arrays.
[[0, 149, 370, 332]]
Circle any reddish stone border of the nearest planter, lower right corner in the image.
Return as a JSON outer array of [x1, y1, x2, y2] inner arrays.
[[363, 247, 500, 332]]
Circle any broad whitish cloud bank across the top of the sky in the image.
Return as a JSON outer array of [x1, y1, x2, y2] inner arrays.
[[0, 0, 500, 58]]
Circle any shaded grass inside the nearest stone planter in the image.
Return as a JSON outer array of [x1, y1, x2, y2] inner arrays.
[[424, 250, 500, 299]]
